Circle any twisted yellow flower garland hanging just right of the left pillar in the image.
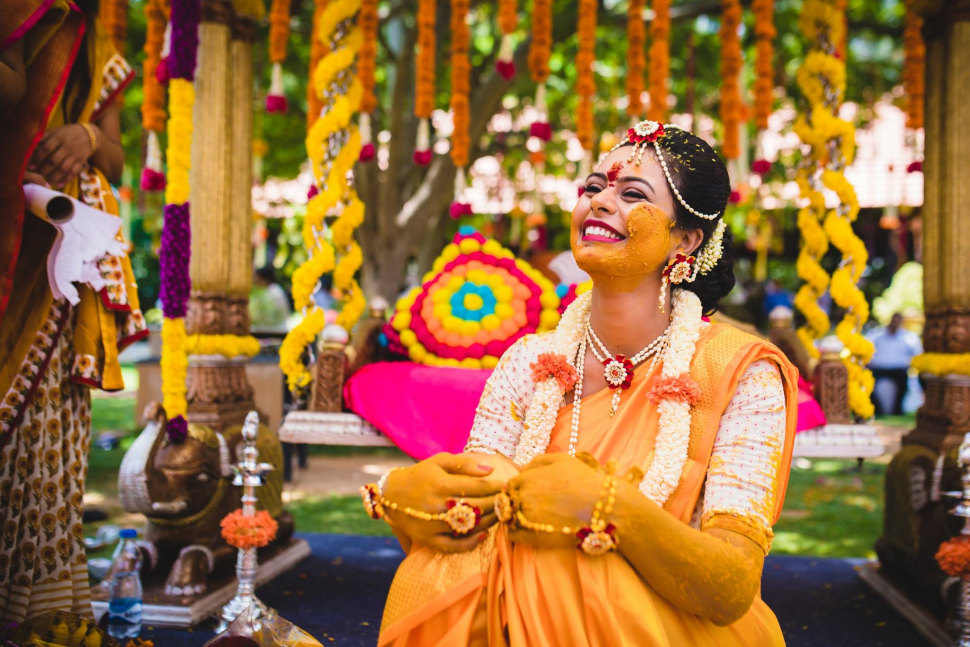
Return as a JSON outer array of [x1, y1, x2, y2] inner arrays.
[[280, 0, 366, 392]]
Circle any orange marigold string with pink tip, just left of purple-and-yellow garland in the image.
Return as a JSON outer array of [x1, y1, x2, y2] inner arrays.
[[140, 0, 168, 191]]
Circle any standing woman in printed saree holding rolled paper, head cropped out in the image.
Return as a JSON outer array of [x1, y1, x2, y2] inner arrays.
[[0, 0, 147, 621]]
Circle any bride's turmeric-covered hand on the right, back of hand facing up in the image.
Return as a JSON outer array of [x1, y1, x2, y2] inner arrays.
[[508, 454, 605, 548]]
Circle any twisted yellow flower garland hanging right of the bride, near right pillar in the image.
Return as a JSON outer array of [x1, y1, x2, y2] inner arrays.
[[794, 0, 874, 418]]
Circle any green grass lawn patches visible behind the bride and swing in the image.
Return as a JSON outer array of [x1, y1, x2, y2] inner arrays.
[[85, 397, 885, 557]]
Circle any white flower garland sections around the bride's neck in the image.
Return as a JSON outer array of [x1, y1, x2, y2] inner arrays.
[[506, 290, 703, 505]]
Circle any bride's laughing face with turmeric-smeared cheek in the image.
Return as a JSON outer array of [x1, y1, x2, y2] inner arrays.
[[570, 146, 684, 291]]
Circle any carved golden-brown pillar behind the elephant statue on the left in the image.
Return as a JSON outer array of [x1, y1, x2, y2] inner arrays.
[[186, 0, 255, 430]]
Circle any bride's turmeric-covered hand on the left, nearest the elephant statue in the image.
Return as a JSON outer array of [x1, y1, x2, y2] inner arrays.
[[383, 454, 504, 553]]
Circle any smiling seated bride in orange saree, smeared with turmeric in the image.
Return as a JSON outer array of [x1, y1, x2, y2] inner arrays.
[[362, 122, 797, 647]]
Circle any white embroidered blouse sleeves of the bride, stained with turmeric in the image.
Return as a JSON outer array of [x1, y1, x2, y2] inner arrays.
[[465, 336, 786, 553]]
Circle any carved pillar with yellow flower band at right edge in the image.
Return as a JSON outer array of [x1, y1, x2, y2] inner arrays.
[[903, 0, 970, 451]]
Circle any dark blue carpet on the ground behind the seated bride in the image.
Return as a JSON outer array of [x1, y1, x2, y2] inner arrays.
[[142, 534, 928, 647]]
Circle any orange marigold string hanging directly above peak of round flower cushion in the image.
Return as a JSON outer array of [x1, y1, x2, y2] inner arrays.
[[451, 0, 471, 218]]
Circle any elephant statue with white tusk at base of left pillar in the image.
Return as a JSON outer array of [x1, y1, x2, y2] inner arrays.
[[116, 404, 294, 597]]
